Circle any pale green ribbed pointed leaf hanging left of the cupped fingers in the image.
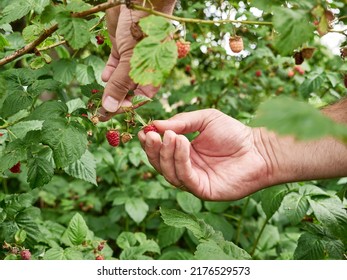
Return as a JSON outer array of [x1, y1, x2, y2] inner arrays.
[[64, 150, 97, 186]]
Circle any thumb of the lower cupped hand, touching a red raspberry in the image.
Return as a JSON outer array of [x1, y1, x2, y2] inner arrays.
[[153, 109, 223, 134]]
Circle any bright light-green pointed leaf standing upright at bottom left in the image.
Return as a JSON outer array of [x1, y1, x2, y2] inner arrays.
[[64, 213, 88, 245]]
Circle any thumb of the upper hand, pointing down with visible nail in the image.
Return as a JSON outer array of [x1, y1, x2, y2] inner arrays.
[[102, 52, 136, 113]]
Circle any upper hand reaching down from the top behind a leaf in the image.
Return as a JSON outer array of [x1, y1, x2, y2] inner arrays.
[[100, 0, 176, 121]]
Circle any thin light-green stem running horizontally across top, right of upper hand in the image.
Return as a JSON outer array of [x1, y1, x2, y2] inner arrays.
[[131, 5, 272, 25]]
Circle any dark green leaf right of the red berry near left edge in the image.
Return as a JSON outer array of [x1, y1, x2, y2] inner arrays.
[[28, 157, 54, 188]]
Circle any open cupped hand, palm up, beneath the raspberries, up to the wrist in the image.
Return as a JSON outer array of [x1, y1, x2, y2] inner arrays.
[[138, 109, 271, 201]]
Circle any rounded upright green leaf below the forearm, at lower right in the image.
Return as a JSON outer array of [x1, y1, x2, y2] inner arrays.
[[283, 192, 309, 224]]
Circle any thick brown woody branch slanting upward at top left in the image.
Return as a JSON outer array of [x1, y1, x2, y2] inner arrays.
[[0, 0, 125, 66]]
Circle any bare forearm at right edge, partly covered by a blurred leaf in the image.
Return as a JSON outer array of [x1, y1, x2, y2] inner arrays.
[[257, 99, 347, 185]]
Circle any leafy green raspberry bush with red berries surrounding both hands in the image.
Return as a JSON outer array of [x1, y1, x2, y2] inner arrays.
[[0, 0, 347, 260]]
